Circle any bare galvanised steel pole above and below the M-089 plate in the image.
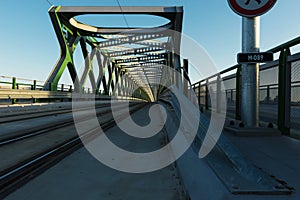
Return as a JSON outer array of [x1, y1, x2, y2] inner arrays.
[[241, 17, 260, 127]]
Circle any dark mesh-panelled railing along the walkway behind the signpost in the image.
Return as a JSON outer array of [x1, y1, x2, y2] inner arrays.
[[190, 37, 300, 135]]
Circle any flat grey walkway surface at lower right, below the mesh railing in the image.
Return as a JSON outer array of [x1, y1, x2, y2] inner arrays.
[[225, 132, 300, 192]]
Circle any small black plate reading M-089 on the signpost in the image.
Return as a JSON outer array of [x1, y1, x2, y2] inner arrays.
[[237, 52, 274, 64]]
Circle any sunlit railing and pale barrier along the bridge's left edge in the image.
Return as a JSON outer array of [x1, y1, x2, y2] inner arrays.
[[0, 76, 142, 104]]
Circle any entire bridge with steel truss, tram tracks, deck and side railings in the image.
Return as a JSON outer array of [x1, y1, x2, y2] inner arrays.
[[0, 1, 300, 200]]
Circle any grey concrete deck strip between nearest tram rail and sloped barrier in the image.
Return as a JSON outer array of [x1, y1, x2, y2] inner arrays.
[[7, 104, 184, 200]]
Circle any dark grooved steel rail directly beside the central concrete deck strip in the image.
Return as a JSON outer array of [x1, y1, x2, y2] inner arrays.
[[0, 104, 145, 199]]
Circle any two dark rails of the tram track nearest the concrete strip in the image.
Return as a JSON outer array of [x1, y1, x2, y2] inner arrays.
[[0, 103, 145, 199]]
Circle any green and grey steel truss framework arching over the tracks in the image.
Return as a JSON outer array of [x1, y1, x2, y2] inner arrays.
[[44, 6, 183, 101]]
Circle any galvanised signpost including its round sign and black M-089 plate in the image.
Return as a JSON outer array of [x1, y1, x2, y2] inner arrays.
[[228, 0, 276, 128]]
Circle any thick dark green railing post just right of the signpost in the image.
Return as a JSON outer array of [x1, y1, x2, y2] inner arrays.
[[278, 49, 291, 135]]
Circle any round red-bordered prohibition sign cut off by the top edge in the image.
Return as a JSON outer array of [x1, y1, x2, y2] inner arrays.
[[228, 0, 277, 17]]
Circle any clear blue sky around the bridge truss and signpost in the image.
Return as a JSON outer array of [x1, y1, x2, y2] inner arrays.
[[0, 0, 300, 81]]
